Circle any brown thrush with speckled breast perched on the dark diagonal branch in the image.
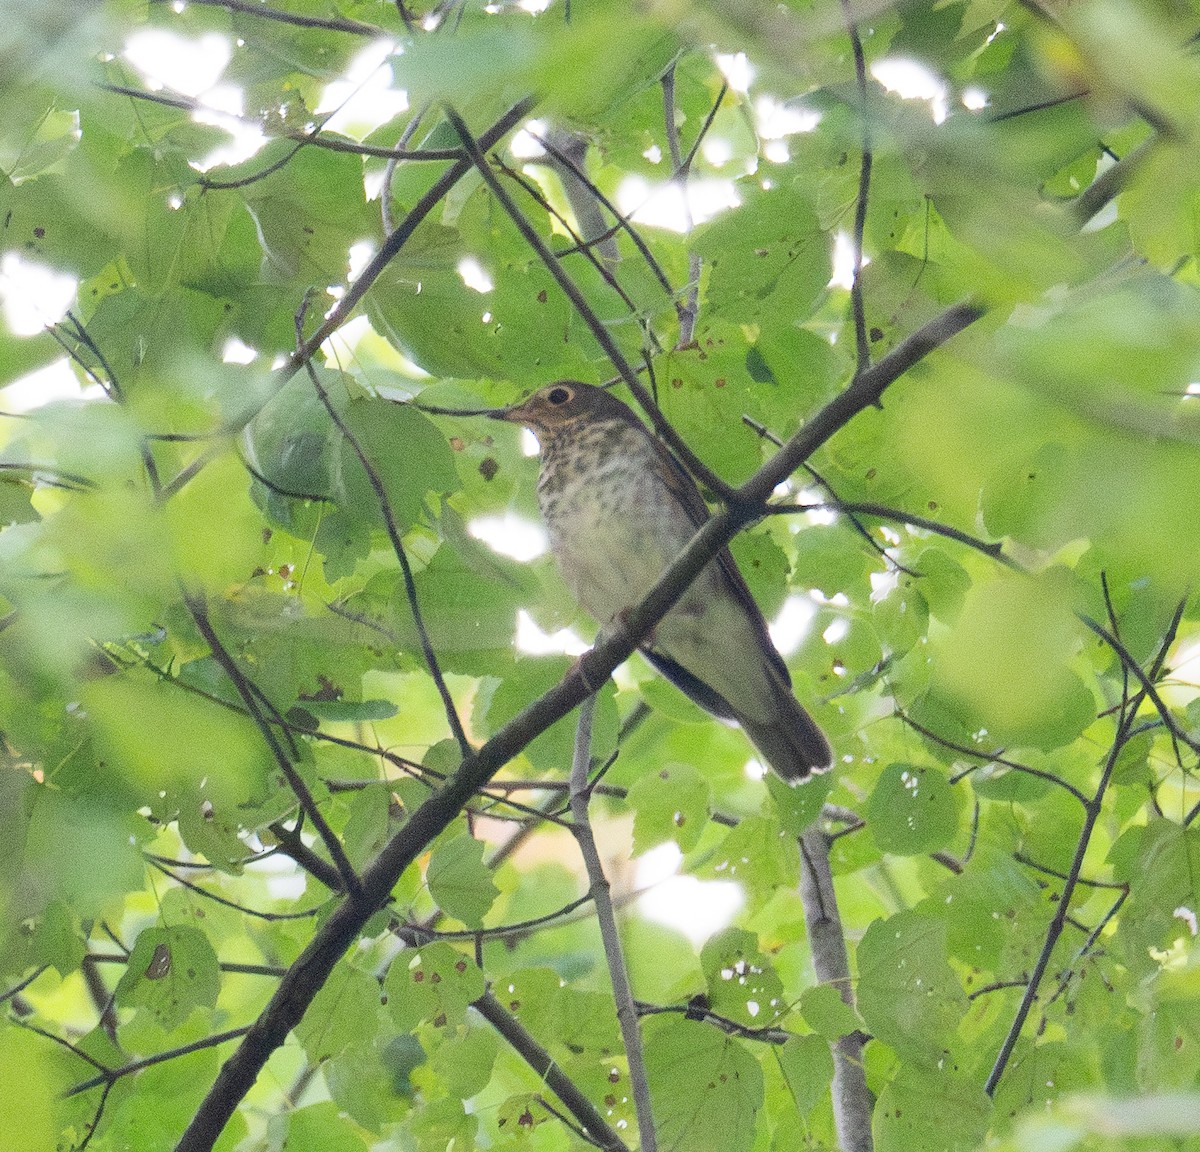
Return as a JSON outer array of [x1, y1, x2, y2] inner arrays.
[[492, 380, 833, 785]]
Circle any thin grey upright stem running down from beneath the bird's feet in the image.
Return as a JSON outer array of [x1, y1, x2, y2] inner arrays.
[[571, 696, 658, 1152]]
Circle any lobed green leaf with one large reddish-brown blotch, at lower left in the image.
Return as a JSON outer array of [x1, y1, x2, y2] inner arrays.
[[115, 925, 221, 1032]]
